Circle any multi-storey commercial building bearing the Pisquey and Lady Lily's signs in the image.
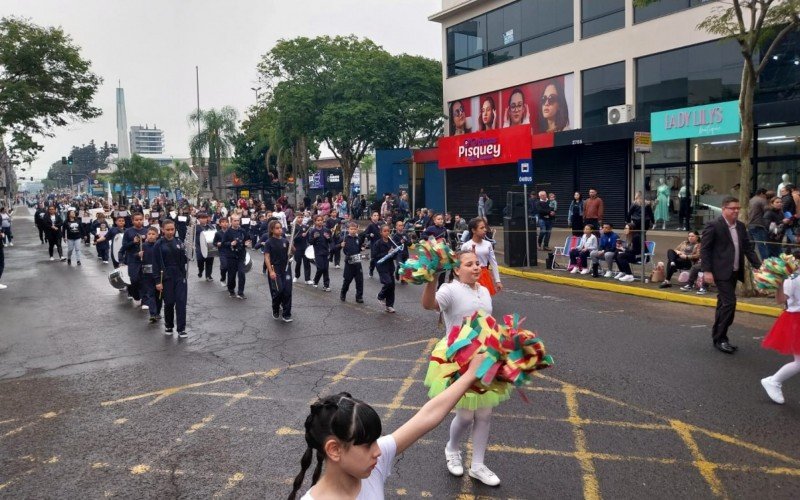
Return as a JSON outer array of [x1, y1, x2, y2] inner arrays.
[[429, 0, 800, 229]]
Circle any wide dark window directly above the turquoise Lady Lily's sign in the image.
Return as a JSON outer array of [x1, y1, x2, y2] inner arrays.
[[636, 40, 742, 120]]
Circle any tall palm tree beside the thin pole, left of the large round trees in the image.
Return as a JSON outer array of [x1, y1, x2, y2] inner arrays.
[[189, 106, 237, 197]]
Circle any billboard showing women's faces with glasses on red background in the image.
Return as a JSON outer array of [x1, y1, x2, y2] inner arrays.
[[448, 74, 575, 135]]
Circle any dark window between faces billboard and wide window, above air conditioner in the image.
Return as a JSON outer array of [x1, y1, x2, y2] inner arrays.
[[583, 62, 625, 128]]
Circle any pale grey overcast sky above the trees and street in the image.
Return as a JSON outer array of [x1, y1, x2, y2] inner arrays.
[[0, 0, 442, 179]]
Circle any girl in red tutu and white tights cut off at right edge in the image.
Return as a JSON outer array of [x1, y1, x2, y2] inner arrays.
[[761, 270, 800, 404]]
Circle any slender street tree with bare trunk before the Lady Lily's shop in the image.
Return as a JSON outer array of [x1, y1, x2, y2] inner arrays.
[[634, 0, 800, 294]]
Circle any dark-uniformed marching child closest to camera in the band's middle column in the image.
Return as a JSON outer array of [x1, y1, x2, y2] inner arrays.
[[261, 219, 292, 323]]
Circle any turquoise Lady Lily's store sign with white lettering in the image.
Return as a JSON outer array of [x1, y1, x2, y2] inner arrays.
[[650, 101, 742, 142]]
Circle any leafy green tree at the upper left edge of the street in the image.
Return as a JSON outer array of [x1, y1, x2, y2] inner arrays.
[[0, 17, 102, 161]]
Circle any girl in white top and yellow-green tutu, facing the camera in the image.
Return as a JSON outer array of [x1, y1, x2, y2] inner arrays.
[[422, 249, 510, 486]]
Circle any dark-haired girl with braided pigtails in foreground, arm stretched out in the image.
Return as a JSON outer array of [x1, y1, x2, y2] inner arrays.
[[289, 354, 486, 500]]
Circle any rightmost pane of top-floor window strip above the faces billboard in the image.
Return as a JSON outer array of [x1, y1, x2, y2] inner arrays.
[[521, 0, 574, 55]]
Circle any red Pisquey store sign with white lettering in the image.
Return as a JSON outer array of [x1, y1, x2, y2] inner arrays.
[[439, 125, 532, 169]]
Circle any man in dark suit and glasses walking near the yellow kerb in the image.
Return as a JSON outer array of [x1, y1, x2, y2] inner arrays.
[[700, 196, 761, 354]]
